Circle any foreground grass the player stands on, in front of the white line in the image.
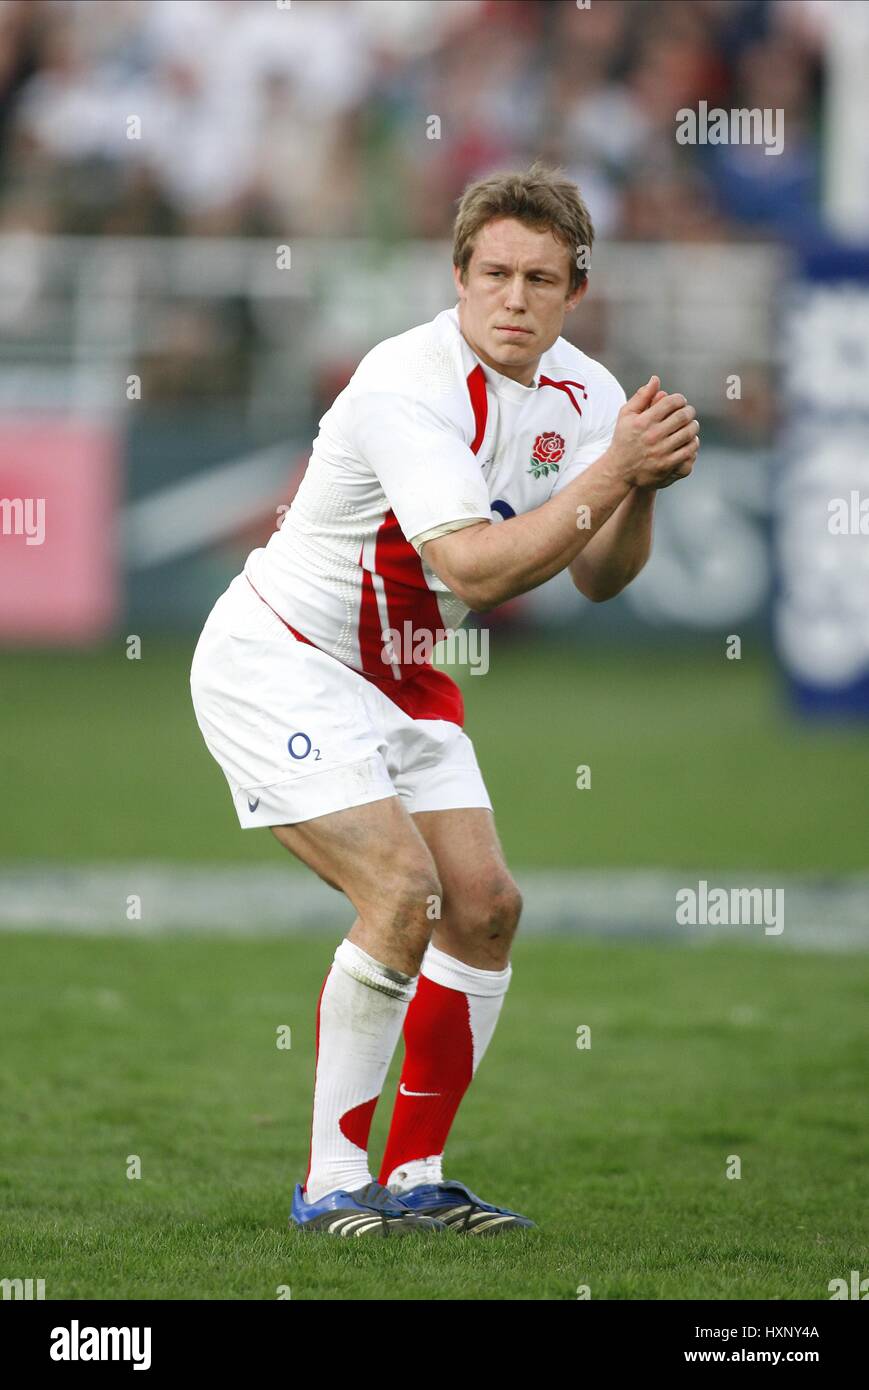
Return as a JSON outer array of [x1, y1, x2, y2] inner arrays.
[[0, 935, 869, 1300]]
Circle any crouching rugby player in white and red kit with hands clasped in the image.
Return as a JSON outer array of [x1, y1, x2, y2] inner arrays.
[[190, 163, 699, 1237]]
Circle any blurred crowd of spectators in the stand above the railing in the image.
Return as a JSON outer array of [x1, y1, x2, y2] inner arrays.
[[0, 0, 830, 242]]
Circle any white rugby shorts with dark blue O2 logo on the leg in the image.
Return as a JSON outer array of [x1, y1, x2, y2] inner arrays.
[[190, 574, 492, 830]]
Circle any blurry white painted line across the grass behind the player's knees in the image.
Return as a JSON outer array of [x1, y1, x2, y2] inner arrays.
[[0, 863, 869, 951]]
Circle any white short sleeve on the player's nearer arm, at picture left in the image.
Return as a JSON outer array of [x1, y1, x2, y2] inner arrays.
[[349, 392, 491, 538]]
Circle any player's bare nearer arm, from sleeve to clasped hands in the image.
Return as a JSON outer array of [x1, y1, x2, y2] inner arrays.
[[421, 377, 698, 613]]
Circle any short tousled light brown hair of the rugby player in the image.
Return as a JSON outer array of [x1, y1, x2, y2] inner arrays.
[[453, 160, 595, 291]]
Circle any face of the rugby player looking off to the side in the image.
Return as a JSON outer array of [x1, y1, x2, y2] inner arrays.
[[453, 217, 588, 386]]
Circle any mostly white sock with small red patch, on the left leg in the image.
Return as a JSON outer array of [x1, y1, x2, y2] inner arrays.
[[304, 940, 417, 1202]]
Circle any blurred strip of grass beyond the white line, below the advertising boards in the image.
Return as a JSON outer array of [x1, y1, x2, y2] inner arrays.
[[0, 632, 869, 874]]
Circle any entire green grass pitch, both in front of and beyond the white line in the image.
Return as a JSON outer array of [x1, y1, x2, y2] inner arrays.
[[0, 632, 869, 1300]]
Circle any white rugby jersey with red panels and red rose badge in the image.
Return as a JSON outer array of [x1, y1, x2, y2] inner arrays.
[[245, 304, 626, 723]]
